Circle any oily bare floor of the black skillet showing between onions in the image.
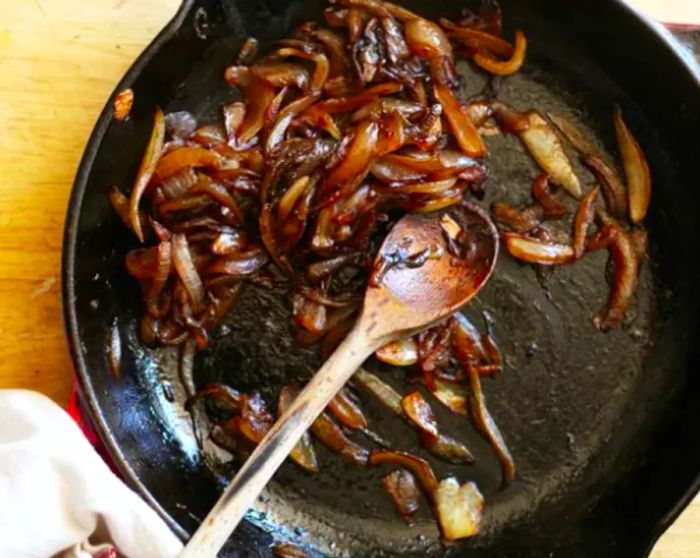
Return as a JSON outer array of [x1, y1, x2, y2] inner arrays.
[[130, 65, 660, 556]]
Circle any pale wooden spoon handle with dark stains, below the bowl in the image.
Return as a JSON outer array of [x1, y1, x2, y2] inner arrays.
[[179, 322, 381, 558]]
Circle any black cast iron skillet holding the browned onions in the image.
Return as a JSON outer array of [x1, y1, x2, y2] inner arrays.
[[63, 0, 700, 558]]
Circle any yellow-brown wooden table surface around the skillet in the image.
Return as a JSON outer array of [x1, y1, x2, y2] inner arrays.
[[0, 0, 700, 558]]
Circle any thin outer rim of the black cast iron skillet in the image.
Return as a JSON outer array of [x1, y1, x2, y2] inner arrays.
[[61, 0, 700, 557]]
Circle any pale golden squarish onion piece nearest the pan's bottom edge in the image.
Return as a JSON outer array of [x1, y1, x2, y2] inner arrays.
[[433, 477, 484, 541]]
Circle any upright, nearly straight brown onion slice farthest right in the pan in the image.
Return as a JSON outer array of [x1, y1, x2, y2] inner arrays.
[[613, 108, 651, 224]]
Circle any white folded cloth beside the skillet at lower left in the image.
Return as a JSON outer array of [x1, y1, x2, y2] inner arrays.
[[0, 390, 182, 558]]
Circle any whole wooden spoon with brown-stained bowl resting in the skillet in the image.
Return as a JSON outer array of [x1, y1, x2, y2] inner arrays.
[[180, 204, 498, 558]]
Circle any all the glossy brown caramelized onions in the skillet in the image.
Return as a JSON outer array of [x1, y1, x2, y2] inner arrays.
[[109, 0, 651, 544]]
